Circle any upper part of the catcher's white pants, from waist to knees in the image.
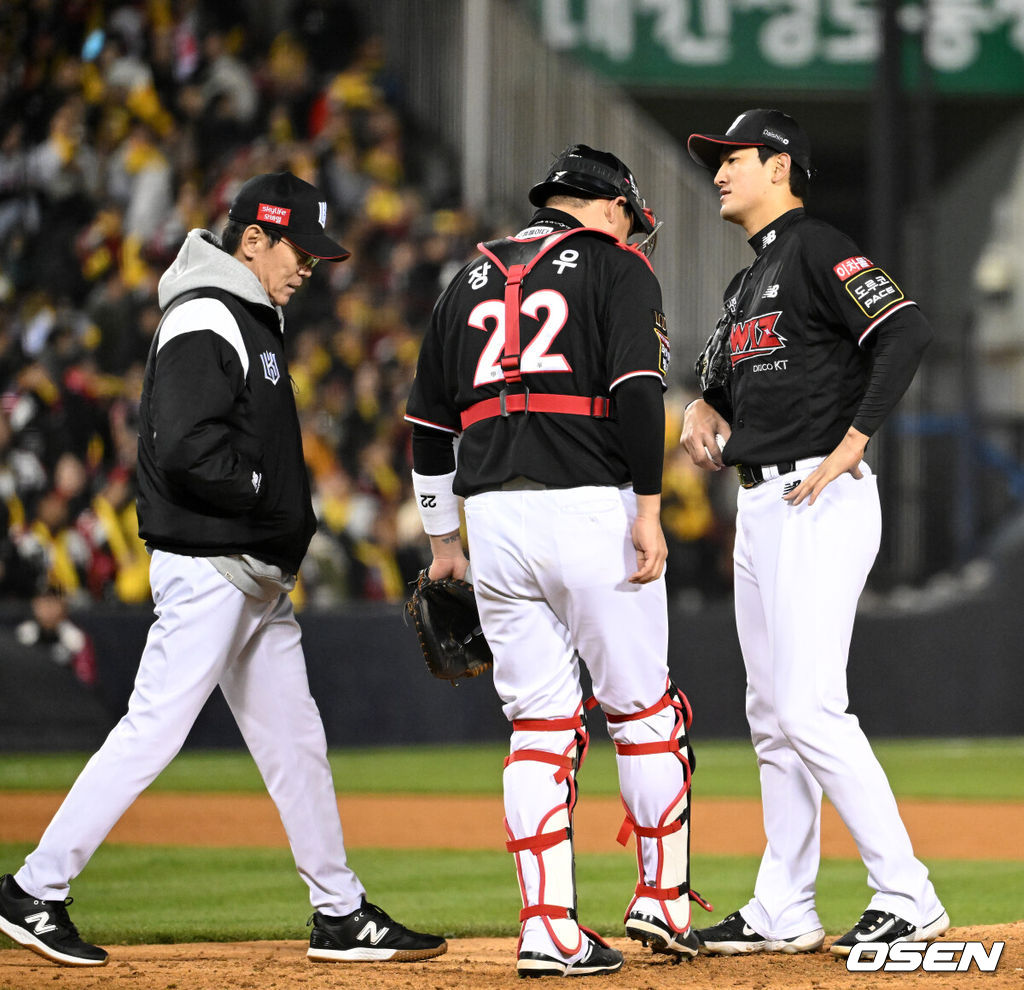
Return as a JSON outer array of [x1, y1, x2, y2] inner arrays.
[[466, 486, 669, 722]]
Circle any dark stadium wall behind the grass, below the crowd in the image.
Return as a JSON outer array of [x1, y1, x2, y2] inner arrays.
[[0, 540, 1024, 751]]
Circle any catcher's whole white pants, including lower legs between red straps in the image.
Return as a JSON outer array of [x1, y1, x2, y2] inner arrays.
[[466, 486, 689, 959]]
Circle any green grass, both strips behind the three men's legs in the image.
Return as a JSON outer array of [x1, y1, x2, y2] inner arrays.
[[0, 738, 1024, 946]]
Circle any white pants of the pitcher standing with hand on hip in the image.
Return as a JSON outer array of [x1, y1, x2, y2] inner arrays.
[[733, 463, 942, 939]]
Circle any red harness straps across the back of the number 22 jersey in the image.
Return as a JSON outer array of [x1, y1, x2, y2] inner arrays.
[[461, 227, 618, 430]]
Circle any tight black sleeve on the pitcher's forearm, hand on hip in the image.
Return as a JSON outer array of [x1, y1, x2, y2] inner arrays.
[[853, 306, 932, 436]]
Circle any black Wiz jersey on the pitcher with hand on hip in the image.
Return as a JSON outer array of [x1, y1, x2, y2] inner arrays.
[[712, 209, 915, 464]]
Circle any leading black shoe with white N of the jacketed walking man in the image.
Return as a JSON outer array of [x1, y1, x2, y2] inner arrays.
[[306, 900, 447, 962]]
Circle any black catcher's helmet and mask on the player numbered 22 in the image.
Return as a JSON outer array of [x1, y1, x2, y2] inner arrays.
[[529, 144, 663, 257]]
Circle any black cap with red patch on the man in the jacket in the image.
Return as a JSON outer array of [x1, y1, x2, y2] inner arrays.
[[227, 172, 351, 261]]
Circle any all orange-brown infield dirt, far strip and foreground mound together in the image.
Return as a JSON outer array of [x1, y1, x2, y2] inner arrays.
[[0, 792, 1024, 990]]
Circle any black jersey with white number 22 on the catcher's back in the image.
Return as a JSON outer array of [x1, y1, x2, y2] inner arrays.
[[406, 209, 669, 496]]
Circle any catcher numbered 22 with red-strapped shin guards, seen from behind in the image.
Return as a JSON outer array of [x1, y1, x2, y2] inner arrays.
[[406, 144, 698, 978]]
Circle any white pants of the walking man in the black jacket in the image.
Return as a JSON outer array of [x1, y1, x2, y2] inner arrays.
[[15, 550, 364, 915]]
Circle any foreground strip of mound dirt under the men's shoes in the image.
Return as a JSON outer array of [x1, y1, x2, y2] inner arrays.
[[0, 921, 1024, 990]]
